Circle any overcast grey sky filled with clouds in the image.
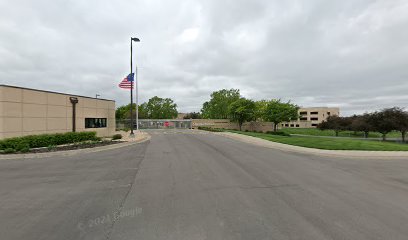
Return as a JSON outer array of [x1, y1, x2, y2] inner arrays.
[[0, 0, 408, 115]]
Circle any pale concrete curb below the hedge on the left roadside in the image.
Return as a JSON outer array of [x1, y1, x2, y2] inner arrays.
[[0, 134, 151, 160]]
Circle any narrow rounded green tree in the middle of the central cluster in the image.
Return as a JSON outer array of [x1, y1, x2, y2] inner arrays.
[[228, 98, 255, 131]]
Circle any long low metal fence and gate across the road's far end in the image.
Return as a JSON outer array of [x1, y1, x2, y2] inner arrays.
[[116, 119, 192, 129]]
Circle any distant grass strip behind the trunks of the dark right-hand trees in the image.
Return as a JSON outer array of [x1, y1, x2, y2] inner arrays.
[[279, 128, 401, 138]]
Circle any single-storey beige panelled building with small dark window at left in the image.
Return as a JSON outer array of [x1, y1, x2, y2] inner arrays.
[[0, 85, 115, 139]]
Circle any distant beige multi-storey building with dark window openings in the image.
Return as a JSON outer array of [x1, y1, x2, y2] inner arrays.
[[281, 107, 340, 128]]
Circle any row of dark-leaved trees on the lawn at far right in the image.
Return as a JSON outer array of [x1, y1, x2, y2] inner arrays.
[[317, 107, 408, 142]]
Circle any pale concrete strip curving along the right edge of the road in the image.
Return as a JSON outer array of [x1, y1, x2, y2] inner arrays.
[[218, 132, 408, 159]]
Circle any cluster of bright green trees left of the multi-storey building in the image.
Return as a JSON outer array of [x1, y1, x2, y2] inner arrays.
[[201, 89, 299, 131]]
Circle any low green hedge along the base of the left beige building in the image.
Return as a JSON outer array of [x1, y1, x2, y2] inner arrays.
[[0, 132, 100, 151]]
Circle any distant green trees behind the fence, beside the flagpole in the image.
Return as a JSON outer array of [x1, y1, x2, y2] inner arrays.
[[115, 96, 178, 120]]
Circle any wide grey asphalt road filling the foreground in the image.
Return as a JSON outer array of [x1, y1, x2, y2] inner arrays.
[[0, 131, 408, 240]]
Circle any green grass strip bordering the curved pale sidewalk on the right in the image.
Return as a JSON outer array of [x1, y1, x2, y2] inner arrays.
[[226, 130, 408, 151]]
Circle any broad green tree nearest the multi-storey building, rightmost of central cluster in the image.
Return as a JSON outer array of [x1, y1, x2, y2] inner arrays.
[[262, 99, 299, 132]]
